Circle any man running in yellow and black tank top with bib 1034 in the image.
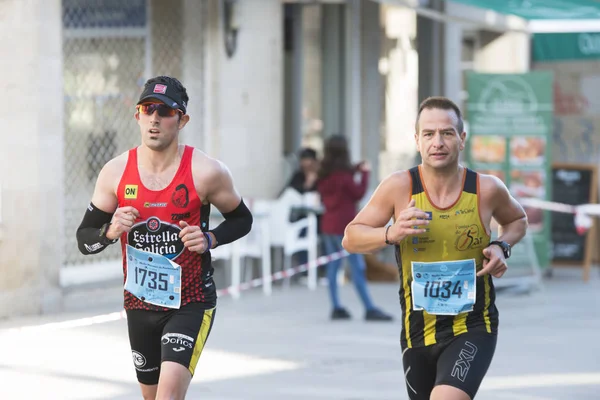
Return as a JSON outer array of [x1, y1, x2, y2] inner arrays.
[[343, 97, 527, 400]]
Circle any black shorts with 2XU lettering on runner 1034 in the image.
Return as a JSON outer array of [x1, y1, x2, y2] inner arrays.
[[402, 332, 497, 400]]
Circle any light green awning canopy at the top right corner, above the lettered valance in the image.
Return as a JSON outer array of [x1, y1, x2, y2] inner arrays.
[[451, 0, 600, 19]]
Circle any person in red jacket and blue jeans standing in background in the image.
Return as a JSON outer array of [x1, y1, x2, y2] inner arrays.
[[317, 135, 392, 321]]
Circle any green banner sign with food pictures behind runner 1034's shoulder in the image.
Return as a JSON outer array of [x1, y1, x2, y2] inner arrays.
[[466, 71, 554, 267]]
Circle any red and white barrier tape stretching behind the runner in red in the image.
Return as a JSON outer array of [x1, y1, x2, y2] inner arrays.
[[0, 250, 349, 335]]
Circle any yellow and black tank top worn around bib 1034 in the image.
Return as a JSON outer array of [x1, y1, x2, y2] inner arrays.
[[396, 167, 498, 348]]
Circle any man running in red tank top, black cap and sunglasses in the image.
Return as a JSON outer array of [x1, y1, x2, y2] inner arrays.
[[77, 76, 252, 400]]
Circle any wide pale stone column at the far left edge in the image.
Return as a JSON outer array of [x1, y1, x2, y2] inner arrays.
[[0, 0, 63, 318]]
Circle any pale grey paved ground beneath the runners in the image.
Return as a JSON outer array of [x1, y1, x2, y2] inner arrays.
[[0, 269, 600, 400]]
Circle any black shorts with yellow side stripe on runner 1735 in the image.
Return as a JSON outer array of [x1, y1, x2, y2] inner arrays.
[[126, 303, 215, 385]]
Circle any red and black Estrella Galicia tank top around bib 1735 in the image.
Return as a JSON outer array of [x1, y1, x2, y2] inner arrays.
[[117, 146, 216, 311]]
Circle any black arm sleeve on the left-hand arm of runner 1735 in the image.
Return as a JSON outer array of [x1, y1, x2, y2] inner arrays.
[[77, 203, 113, 255]]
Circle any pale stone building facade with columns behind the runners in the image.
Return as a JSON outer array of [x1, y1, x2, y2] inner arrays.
[[0, 0, 529, 317]]
